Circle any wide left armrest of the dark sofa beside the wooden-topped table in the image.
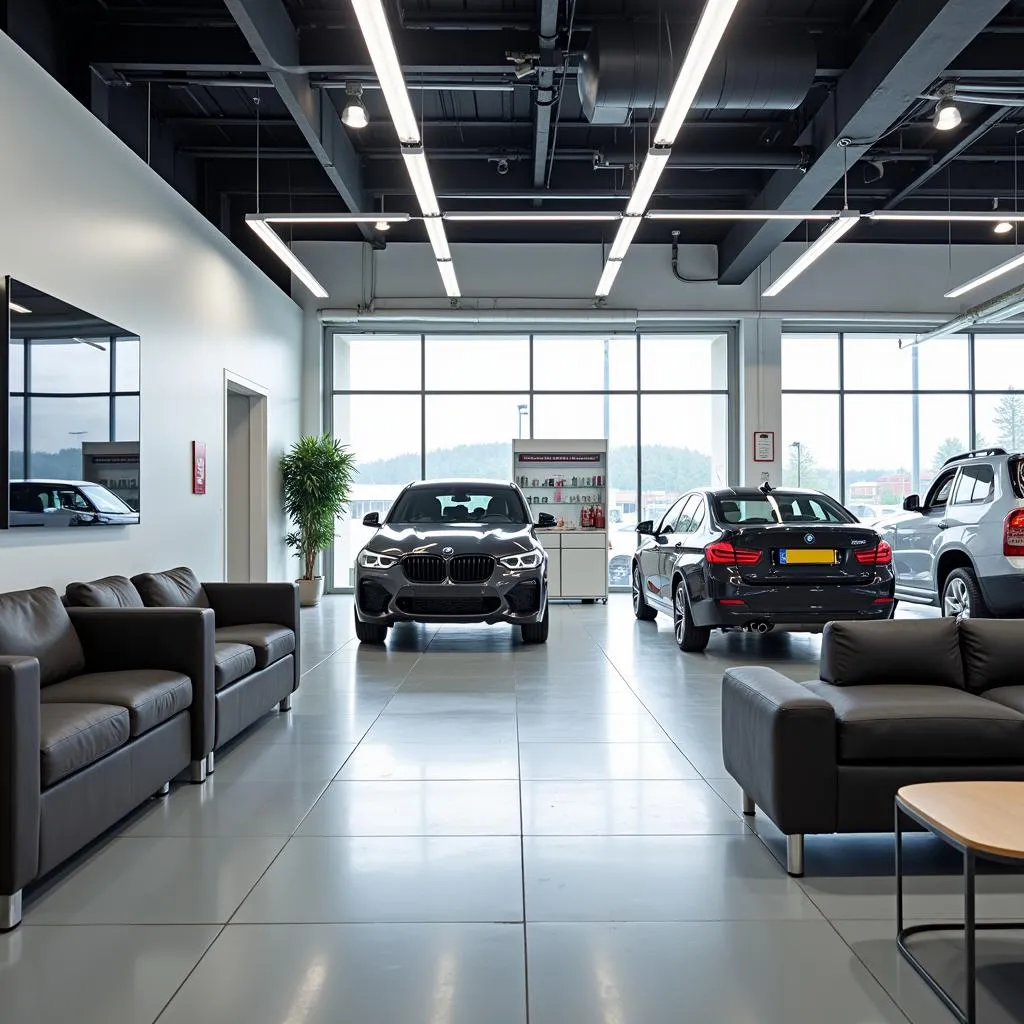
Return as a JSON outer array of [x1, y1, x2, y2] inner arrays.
[[722, 668, 839, 836]]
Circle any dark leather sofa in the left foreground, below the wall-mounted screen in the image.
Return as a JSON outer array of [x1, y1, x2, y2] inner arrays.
[[0, 588, 214, 931]]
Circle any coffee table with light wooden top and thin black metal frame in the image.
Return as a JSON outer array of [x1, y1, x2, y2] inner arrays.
[[896, 782, 1024, 1024]]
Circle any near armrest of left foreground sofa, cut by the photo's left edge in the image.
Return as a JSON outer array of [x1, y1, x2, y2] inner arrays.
[[0, 657, 40, 896]]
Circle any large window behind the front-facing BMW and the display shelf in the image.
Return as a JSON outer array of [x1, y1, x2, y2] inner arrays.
[[327, 332, 733, 590]]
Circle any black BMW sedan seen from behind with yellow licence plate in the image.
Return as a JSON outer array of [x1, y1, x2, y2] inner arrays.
[[633, 485, 895, 651]]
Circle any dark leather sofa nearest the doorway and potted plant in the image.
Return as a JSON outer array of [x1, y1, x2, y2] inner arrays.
[[65, 566, 300, 771]]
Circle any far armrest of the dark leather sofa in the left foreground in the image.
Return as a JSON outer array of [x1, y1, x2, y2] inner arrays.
[[68, 608, 216, 761]]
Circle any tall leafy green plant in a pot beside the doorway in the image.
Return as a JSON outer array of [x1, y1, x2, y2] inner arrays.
[[281, 434, 356, 608]]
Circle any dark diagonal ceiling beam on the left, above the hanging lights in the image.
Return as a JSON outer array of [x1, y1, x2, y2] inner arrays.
[[224, 0, 373, 231]]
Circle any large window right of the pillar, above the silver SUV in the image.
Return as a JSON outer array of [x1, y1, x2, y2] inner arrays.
[[782, 333, 1024, 518]]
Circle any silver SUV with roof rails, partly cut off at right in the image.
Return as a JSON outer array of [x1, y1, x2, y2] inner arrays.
[[874, 449, 1024, 618]]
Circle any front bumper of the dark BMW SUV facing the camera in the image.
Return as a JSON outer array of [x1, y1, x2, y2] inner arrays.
[[355, 569, 548, 626]]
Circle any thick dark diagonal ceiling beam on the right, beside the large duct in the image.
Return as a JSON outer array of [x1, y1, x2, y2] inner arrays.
[[719, 0, 1006, 285]]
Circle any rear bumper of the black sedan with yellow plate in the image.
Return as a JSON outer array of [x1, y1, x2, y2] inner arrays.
[[690, 573, 895, 629]]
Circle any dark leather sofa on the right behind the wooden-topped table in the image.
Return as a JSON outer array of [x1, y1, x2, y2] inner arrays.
[[722, 618, 1024, 874]]
